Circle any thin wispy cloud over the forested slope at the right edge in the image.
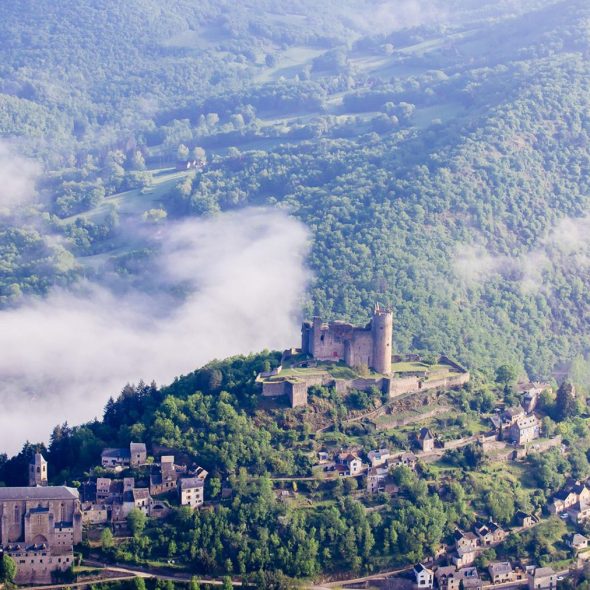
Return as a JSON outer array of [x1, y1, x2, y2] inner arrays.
[[453, 215, 590, 293]]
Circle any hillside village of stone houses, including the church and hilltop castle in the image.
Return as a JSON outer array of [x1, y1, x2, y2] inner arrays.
[[0, 308, 590, 590]]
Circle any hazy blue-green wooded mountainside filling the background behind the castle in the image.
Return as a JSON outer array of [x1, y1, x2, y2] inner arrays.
[[0, 0, 590, 377]]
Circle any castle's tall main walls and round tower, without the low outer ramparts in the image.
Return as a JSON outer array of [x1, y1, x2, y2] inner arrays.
[[301, 305, 393, 375]]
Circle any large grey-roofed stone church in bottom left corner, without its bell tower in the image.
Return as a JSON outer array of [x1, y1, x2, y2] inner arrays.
[[0, 486, 82, 584]]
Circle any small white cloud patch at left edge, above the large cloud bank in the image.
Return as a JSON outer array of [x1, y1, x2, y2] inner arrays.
[[0, 140, 41, 215]]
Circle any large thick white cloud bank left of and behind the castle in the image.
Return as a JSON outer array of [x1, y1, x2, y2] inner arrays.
[[0, 209, 308, 452]]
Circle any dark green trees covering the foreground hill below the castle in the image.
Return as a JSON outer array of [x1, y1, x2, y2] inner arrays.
[[0, 353, 590, 588]]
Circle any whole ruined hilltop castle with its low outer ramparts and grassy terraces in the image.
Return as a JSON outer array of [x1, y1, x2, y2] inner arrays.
[[257, 305, 469, 407]]
